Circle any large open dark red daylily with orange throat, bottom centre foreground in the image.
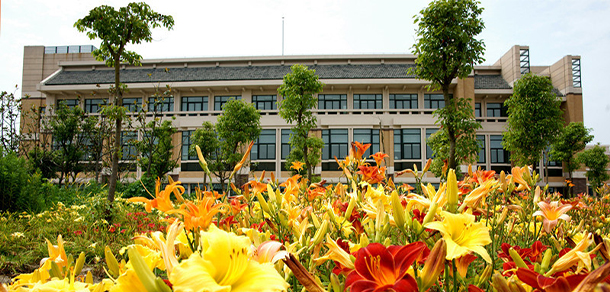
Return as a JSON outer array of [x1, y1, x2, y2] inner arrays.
[[345, 242, 425, 292]]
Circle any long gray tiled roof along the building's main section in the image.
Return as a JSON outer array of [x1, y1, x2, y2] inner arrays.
[[45, 64, 415, 85]]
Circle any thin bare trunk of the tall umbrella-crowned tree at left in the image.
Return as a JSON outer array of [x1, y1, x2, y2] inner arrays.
[[108, 57, 123, 202]]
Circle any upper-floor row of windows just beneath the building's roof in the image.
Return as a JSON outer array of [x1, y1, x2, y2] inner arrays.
[[59, 94, 507, 113]]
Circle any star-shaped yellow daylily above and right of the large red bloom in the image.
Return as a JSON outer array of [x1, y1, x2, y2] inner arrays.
[[424, 211, 491, 263]]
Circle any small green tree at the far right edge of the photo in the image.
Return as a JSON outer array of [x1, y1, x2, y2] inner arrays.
[[578, 143, 610, 195]]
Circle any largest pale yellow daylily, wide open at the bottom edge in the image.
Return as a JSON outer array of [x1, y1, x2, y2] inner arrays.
[[169, 225, 289, 292]]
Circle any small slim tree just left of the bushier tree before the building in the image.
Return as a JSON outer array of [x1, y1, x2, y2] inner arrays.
[[189, 121, 220, 185]]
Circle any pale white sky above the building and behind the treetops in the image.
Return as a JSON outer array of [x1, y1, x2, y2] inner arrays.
[[0, 0, 610, 145]]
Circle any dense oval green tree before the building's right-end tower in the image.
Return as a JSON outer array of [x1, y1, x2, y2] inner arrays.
[[502, 73, 564, 169]]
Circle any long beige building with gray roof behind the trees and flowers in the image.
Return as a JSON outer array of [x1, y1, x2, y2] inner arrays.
[[22, 46, 584, 194]]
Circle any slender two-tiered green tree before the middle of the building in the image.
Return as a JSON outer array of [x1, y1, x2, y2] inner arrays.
[[277, 64, 324, 182]]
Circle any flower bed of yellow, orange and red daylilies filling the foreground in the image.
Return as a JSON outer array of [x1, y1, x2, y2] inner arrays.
[[0, 143, 610, 292]]
